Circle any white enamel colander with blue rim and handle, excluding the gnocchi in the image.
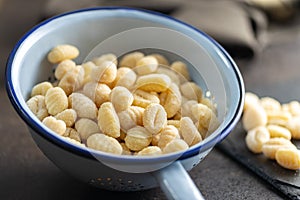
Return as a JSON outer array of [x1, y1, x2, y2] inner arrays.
[[6, 7, 244, 199]]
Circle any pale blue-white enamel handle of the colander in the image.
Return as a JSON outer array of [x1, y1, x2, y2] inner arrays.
[[153, 161, 204, 200]]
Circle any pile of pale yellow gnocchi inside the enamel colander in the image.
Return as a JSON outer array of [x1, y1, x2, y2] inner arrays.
[[26, 44, 220, 156]]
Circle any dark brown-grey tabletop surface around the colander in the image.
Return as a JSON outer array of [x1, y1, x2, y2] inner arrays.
[[0, 0, 300, 200]]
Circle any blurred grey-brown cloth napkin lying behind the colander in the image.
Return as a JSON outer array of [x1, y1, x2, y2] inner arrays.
[[44, 0, 267, 59]]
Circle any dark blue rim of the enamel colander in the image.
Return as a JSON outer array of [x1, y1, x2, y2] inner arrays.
[[5, 6, 245, 160]]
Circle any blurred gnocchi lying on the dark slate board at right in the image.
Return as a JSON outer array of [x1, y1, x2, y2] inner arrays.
[[242, 92, 300, 170]]
